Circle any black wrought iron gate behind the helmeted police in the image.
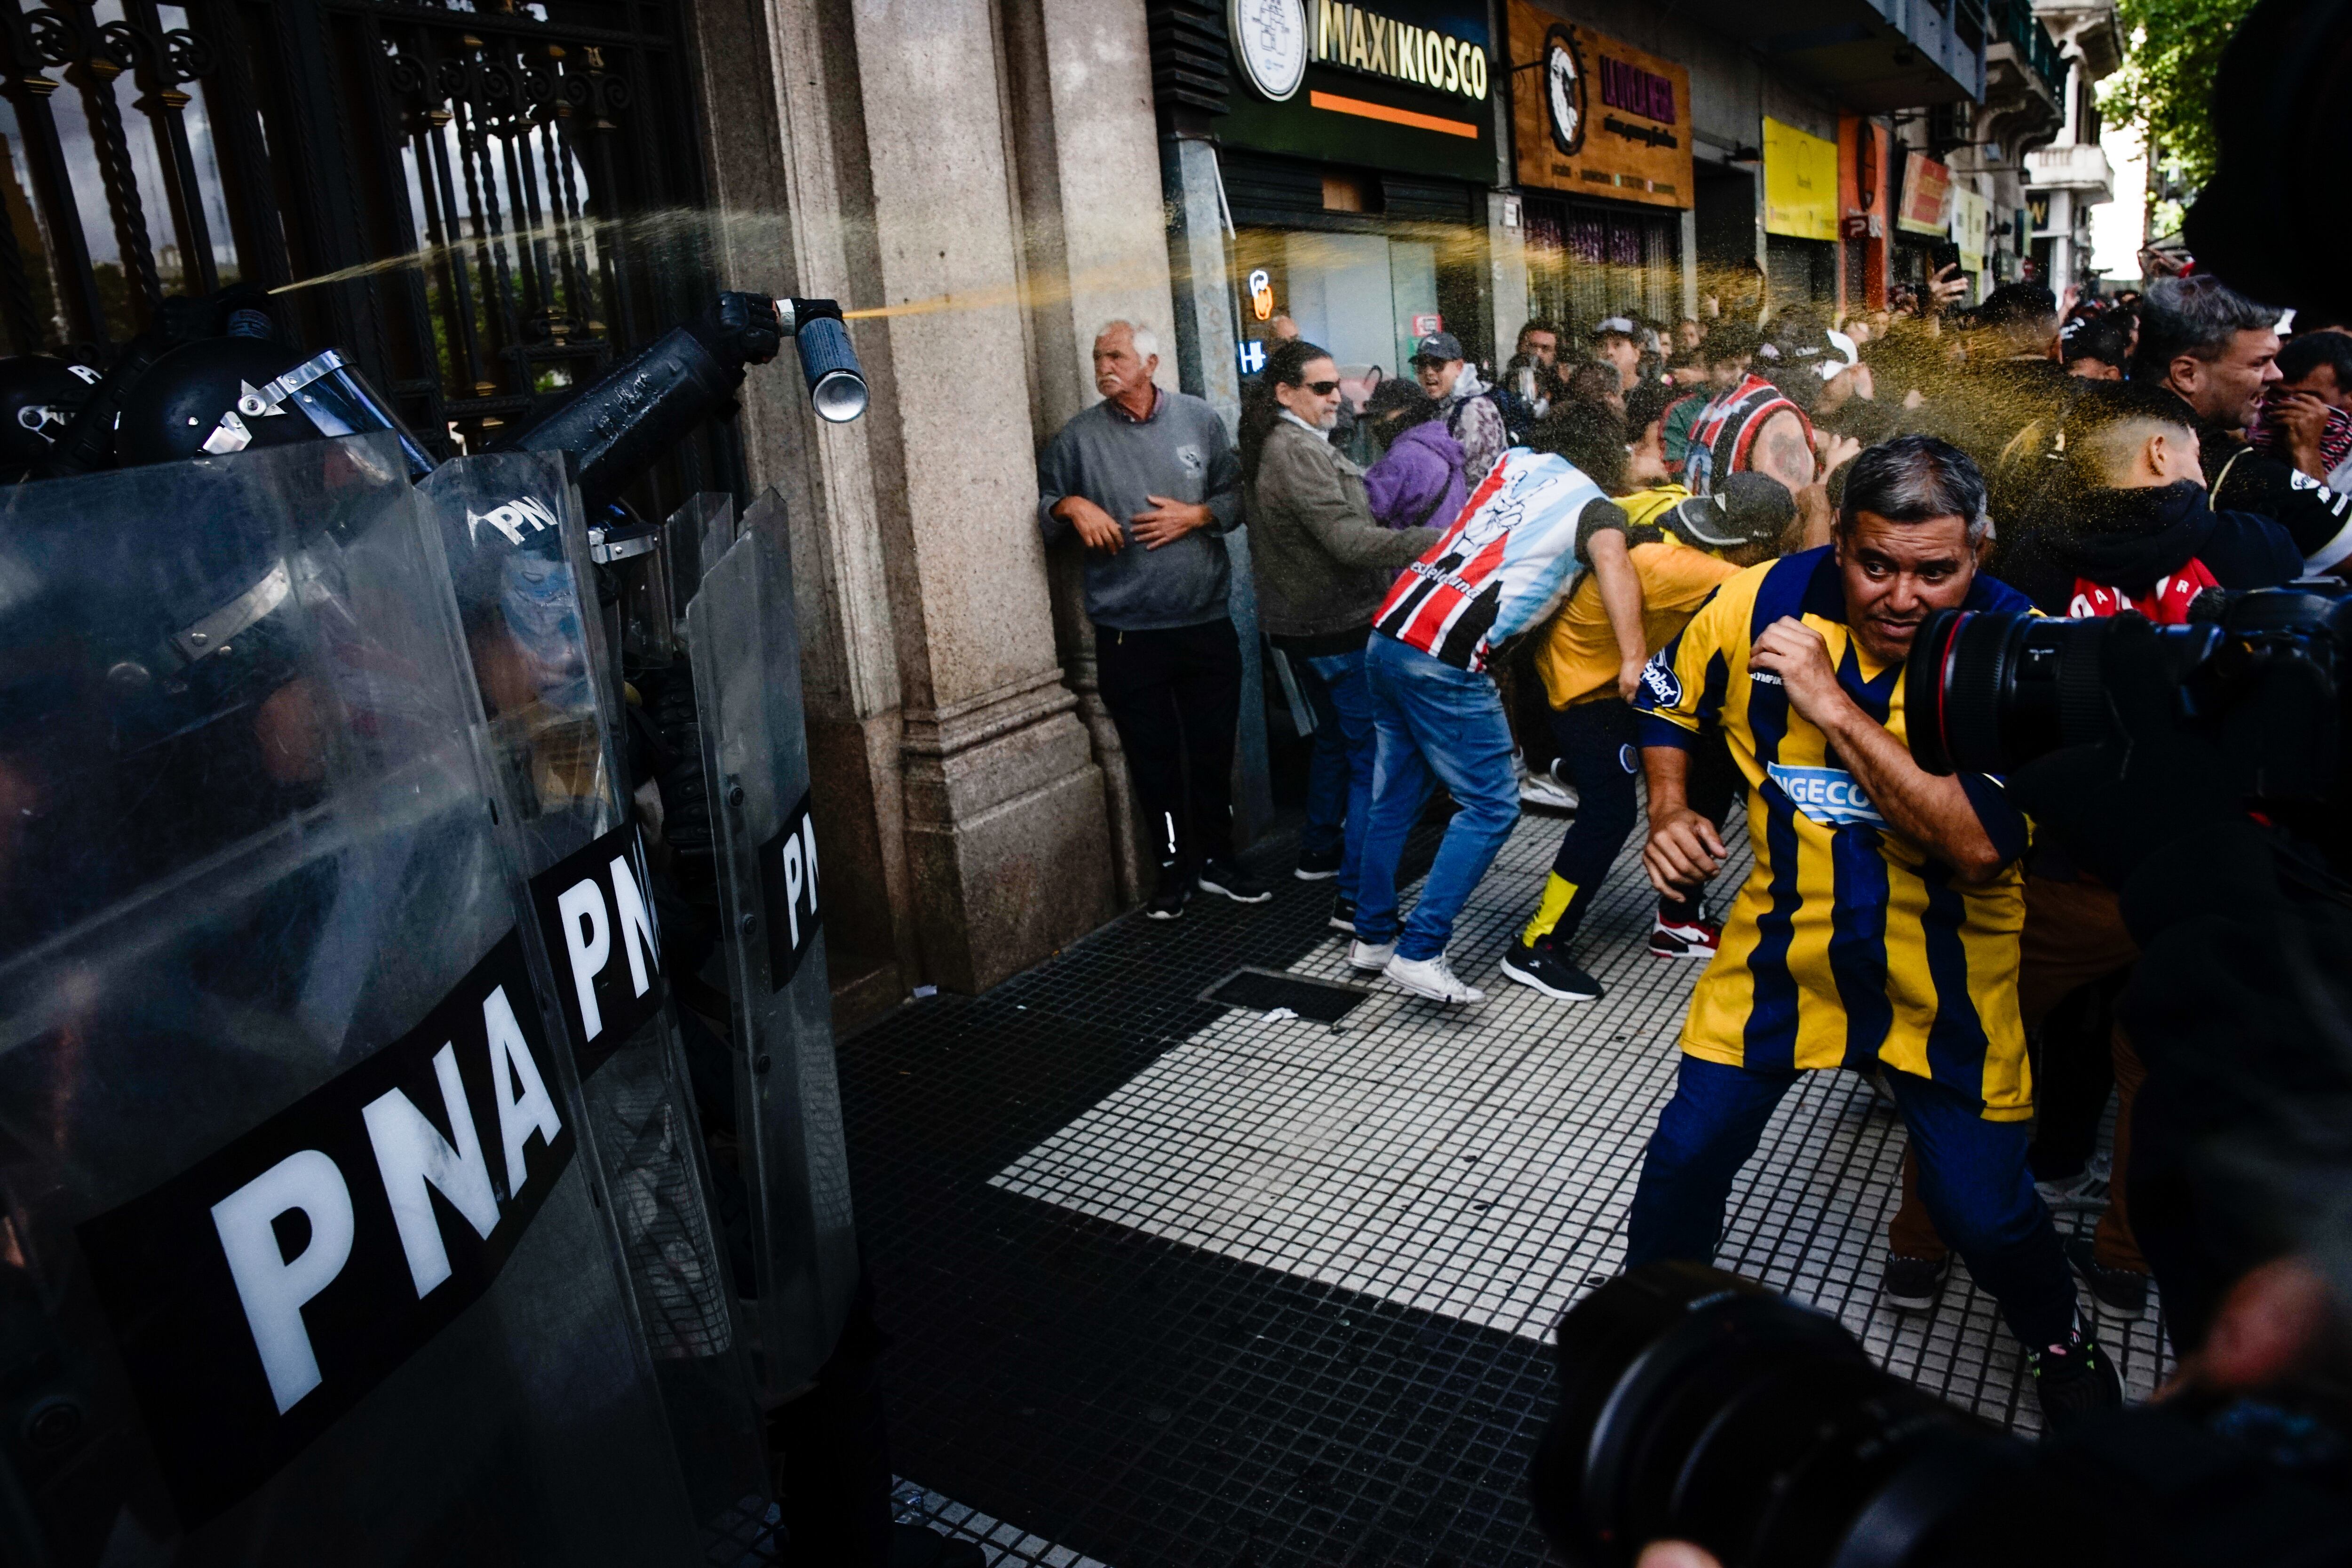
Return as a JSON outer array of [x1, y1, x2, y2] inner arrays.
[[0, 0, 739, 517]]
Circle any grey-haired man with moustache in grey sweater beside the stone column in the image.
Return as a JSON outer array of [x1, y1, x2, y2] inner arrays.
[[1037, 322, 1272, 919]]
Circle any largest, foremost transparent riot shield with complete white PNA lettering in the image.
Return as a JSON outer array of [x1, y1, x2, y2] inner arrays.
[[0, 437, 699, 1566]]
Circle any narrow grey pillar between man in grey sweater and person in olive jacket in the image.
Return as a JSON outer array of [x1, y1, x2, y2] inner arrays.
[[1160, 125, 1275, 846]]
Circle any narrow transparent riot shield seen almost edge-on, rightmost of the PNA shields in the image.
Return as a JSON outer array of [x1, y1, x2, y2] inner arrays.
[[687, 491, 858, 1399]]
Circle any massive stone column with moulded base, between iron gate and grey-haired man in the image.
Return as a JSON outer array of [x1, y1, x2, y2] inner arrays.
[[703, 0, 1115, 992]]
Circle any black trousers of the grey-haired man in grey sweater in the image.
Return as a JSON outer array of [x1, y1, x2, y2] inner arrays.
[[1094, 621, 1242, 870]]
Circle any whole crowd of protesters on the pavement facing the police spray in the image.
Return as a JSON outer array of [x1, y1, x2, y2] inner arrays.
[[1042, 273, 2352, 1422]]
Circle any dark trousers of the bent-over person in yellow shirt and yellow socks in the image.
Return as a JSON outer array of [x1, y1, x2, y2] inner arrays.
[[1519, 696, 1738, 943]]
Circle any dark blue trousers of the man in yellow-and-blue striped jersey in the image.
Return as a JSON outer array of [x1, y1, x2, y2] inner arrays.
[[1625, 1056, 2074, 1347]]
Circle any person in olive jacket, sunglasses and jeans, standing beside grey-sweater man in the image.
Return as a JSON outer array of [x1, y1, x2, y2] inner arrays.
[[1242, 359, 1451, 933]]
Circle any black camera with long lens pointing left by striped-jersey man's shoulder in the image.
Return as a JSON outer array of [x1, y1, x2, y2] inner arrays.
[[1903, 578, 2352, 809]]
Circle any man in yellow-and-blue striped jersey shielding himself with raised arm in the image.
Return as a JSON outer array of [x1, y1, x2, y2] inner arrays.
[[1625, 435, 2122, 1427]]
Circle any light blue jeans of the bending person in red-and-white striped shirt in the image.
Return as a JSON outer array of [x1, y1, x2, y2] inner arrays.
[[1355, 632, 1519, 959]]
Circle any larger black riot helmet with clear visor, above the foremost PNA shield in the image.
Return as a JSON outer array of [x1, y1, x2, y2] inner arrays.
[[115, 336, 433, 479]]
